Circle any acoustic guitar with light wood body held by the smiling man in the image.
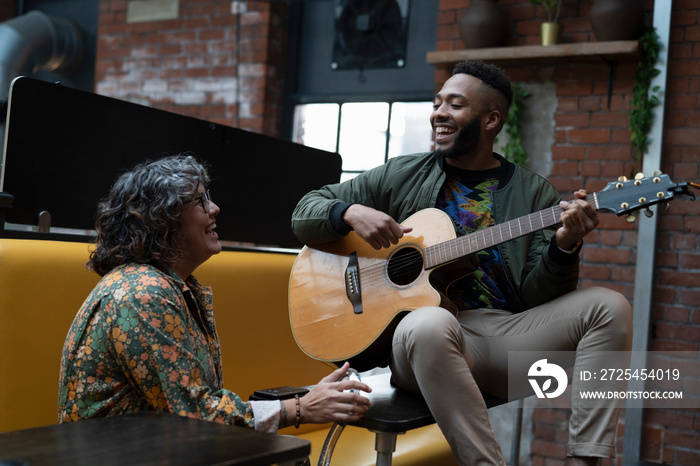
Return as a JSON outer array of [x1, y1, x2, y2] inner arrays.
[[289, 174, 698, 370]]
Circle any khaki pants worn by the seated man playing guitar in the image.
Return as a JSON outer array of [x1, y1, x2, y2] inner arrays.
[[391, 287, 632, 466]]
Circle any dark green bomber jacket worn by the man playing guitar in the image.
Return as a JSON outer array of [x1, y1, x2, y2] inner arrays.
[[292, 152, 581, 312]]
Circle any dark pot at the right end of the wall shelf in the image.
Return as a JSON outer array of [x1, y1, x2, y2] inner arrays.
[[589, 0, 644, 42]]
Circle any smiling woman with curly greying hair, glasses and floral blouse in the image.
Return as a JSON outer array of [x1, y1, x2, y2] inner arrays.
[[58, 155, 371, 440]]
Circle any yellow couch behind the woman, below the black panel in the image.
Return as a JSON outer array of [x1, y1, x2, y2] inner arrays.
[[0, 238, 456, 466]]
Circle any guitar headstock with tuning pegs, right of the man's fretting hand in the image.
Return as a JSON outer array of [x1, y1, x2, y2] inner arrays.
[[595, 172, 696, 222]]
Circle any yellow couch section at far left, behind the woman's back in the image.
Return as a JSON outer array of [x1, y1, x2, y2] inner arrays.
[[0, 239, 100, 432]]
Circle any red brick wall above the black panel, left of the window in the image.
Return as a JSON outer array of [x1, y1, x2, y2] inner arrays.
[[95, 0, 287, 136]]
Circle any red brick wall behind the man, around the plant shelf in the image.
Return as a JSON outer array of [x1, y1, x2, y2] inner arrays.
[[435, 0, 700, 465]]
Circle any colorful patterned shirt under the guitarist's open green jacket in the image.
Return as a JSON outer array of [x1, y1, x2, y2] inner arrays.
[[436, 164, 508, 310]]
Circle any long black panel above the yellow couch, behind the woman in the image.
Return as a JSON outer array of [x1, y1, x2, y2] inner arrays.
[[2, 78, 341, 247]]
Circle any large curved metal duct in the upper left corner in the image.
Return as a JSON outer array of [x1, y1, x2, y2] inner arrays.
[[0, 11, 84, 160]]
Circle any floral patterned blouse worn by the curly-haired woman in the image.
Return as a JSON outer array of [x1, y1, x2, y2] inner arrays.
[[58, 264, 255, 427]]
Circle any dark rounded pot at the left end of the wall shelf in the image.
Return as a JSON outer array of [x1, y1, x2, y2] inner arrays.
[[459, 0, 507, 49]]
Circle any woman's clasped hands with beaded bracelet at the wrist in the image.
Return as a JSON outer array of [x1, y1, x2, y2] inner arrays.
[[283, 362, 372, 425]]
